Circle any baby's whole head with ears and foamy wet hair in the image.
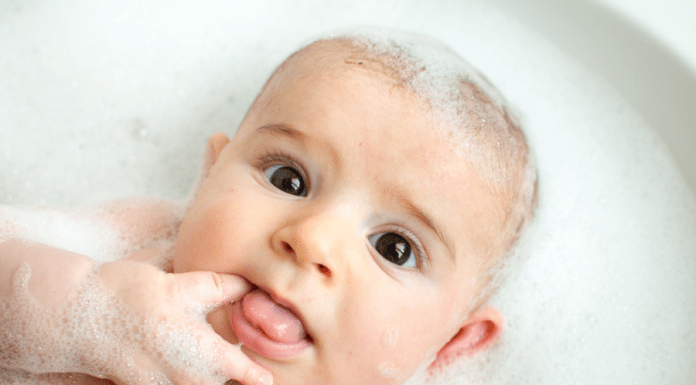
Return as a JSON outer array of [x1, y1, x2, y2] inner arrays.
[[174, 28, 535, 384]]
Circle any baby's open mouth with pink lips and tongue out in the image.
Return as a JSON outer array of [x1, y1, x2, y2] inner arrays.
[[229, 288, 312, 359]]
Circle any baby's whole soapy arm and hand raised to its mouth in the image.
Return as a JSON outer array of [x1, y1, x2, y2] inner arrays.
[[0, 202, 271, 384]]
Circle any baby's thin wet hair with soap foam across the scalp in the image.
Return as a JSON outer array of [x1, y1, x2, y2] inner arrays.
[[252, 27, 537, 296]]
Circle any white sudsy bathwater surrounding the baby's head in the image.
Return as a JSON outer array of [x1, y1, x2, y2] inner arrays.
[[0, 1, 696, 384]]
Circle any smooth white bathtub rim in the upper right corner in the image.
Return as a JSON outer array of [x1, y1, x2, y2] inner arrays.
[[492, 0, 696, 191]]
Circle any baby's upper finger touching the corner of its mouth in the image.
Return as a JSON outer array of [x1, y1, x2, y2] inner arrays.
[[170, 271, 251, 305]]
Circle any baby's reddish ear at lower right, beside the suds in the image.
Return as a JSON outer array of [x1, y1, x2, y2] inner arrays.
[[428, 307, 505, 371]]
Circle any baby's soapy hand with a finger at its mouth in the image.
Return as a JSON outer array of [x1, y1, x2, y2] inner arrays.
[[93, 261, 272, 385]]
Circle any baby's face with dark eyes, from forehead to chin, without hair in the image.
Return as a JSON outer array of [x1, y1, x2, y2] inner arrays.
[[174, 56, 496, 385]]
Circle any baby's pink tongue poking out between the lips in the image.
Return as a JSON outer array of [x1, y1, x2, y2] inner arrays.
[[242, 289, 306, 343]]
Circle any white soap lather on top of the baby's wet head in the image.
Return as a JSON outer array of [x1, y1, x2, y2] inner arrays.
[[324, 27, 536, 194]]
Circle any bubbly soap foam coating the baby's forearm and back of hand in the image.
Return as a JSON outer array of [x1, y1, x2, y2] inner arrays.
[[0, 263, 225, 385]]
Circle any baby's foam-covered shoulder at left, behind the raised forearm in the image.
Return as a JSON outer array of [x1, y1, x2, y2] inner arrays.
[[0, 197, 185, 262]]
